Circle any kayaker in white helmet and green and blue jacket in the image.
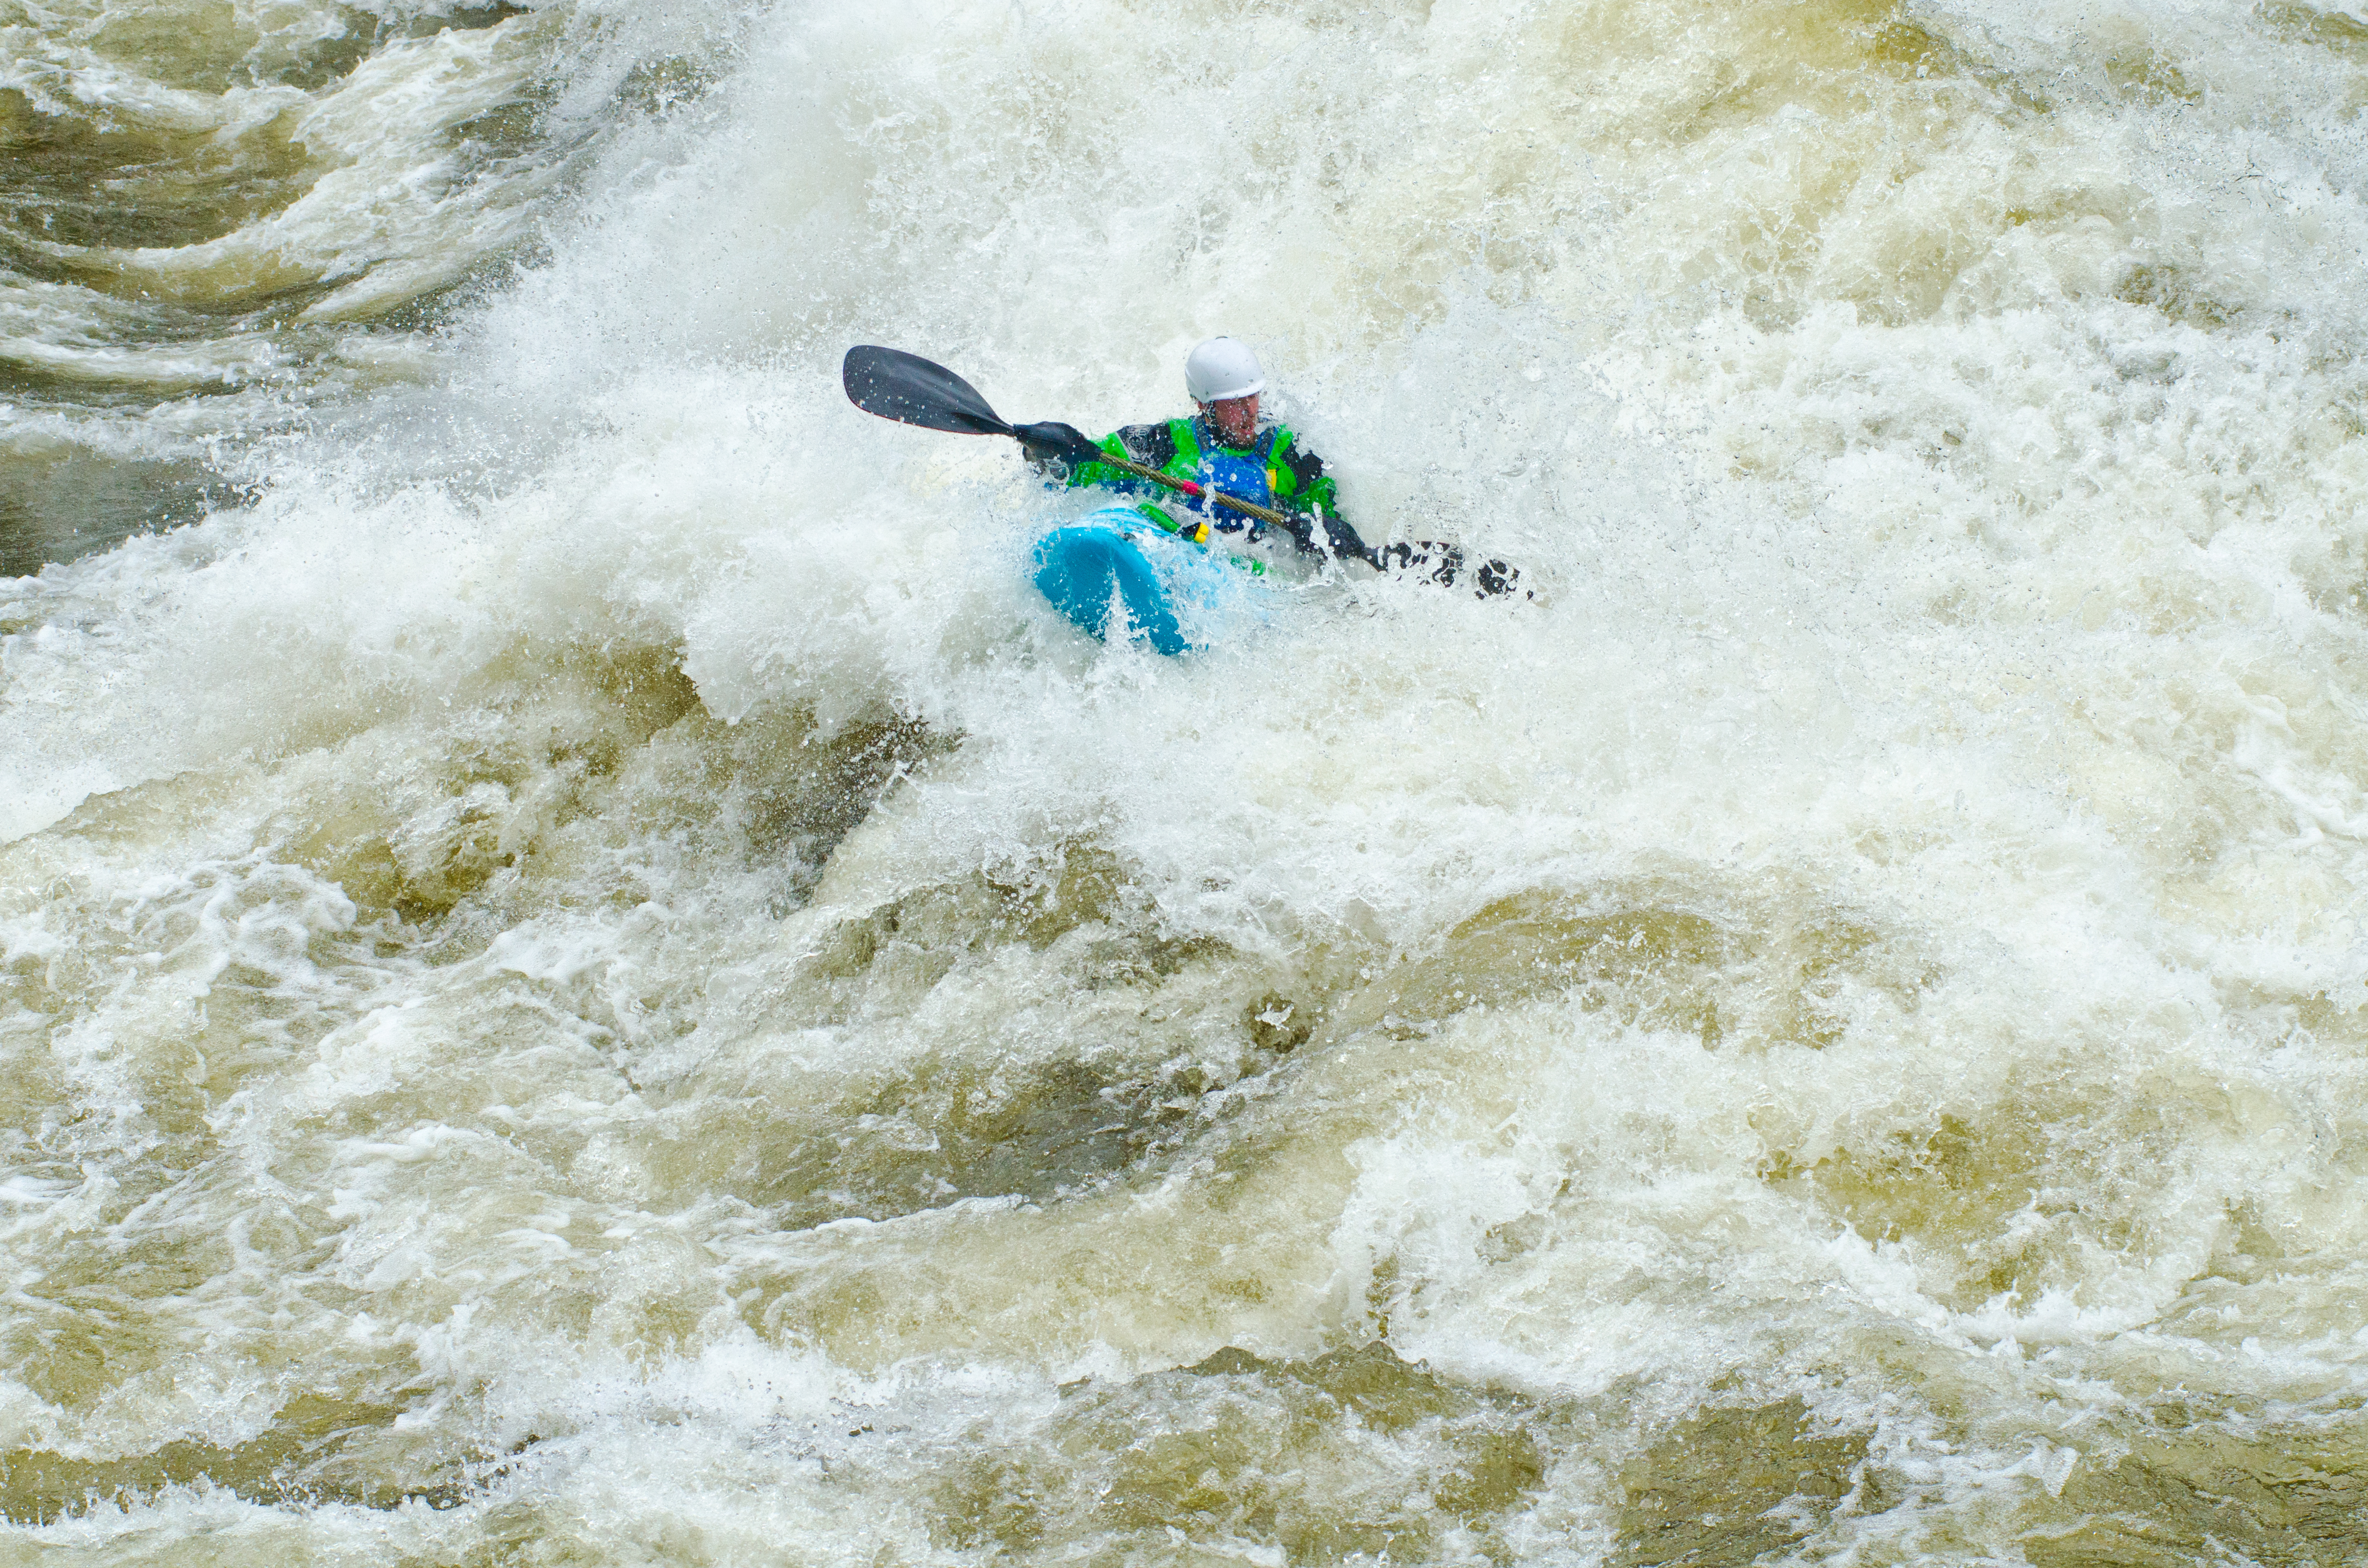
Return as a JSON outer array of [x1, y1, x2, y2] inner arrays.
[[1030, 336, 1392, 580]]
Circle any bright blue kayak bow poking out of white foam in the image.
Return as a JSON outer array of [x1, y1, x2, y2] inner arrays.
[[1035, 507, 1274, 654]]
